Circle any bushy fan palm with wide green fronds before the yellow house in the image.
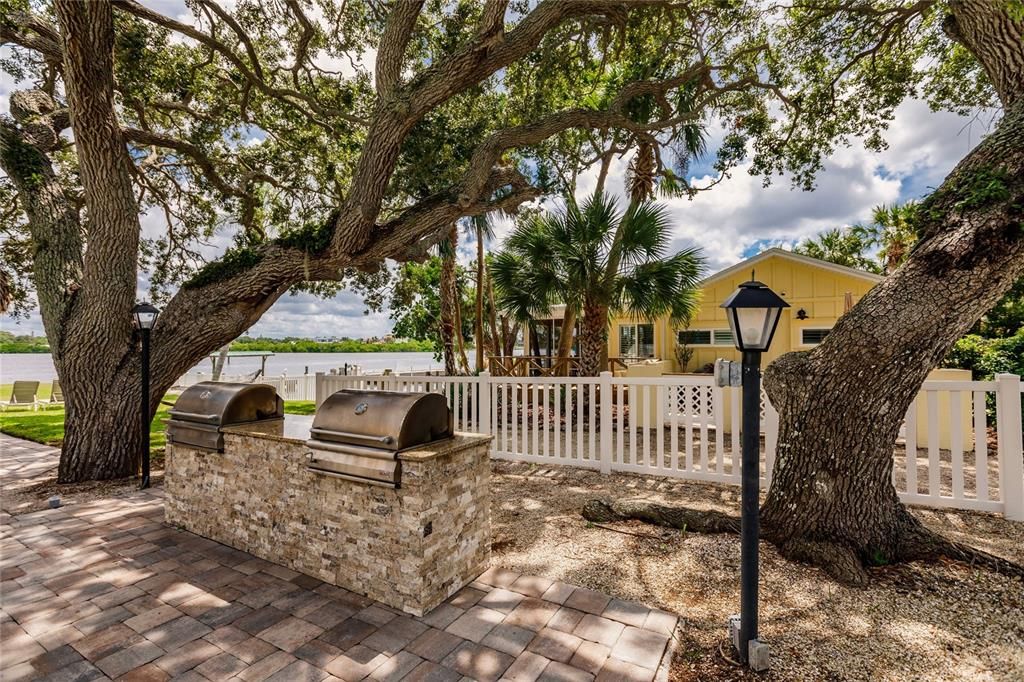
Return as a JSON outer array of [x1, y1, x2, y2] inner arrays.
[[492, 191, 703, 376]]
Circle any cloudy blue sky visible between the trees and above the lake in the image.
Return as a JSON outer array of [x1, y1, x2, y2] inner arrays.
[[0, 0, 991, 338]]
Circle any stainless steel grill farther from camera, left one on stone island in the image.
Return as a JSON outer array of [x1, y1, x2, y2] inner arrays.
[[167, 381, 285, 452]]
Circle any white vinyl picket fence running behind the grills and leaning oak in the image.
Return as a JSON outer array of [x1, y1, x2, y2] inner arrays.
[[314, 372, 1024, 520]]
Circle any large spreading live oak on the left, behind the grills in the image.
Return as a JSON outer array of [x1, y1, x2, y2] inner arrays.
[[0, 0, 780, 481]]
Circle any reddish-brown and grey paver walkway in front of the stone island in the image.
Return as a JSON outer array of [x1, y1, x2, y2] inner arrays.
[[0, 434, 677, 682]]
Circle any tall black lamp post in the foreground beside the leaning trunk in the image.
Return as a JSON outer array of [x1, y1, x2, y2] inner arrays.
[[722, 280, 790, 667]]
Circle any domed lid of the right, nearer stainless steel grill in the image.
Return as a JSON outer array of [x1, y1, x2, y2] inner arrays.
[[309, 389, 453, 453]]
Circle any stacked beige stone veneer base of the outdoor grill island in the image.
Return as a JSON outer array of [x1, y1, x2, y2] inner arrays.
[[165, 431, 490, 615]]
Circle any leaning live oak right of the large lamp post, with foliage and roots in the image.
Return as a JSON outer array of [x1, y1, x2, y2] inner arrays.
[[586, 0, 1024, 585]]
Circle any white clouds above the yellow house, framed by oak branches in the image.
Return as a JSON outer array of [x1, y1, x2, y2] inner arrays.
[[565, 100, 985, 272]]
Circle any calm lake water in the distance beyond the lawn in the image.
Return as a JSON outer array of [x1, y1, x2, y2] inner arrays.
[[0, 353, 473, 384]]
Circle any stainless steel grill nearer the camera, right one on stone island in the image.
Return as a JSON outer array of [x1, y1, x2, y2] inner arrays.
[[306, 389, 453, 487]]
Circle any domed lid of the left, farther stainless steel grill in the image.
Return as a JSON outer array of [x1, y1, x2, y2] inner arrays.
[[170, 381, 285, 427]]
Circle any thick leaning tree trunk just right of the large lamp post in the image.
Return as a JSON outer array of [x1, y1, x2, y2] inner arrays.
[[762, 95, 1024, 583]]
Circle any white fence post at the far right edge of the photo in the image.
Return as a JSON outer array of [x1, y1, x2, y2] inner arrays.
[[995, 374, 1024, 521]]
